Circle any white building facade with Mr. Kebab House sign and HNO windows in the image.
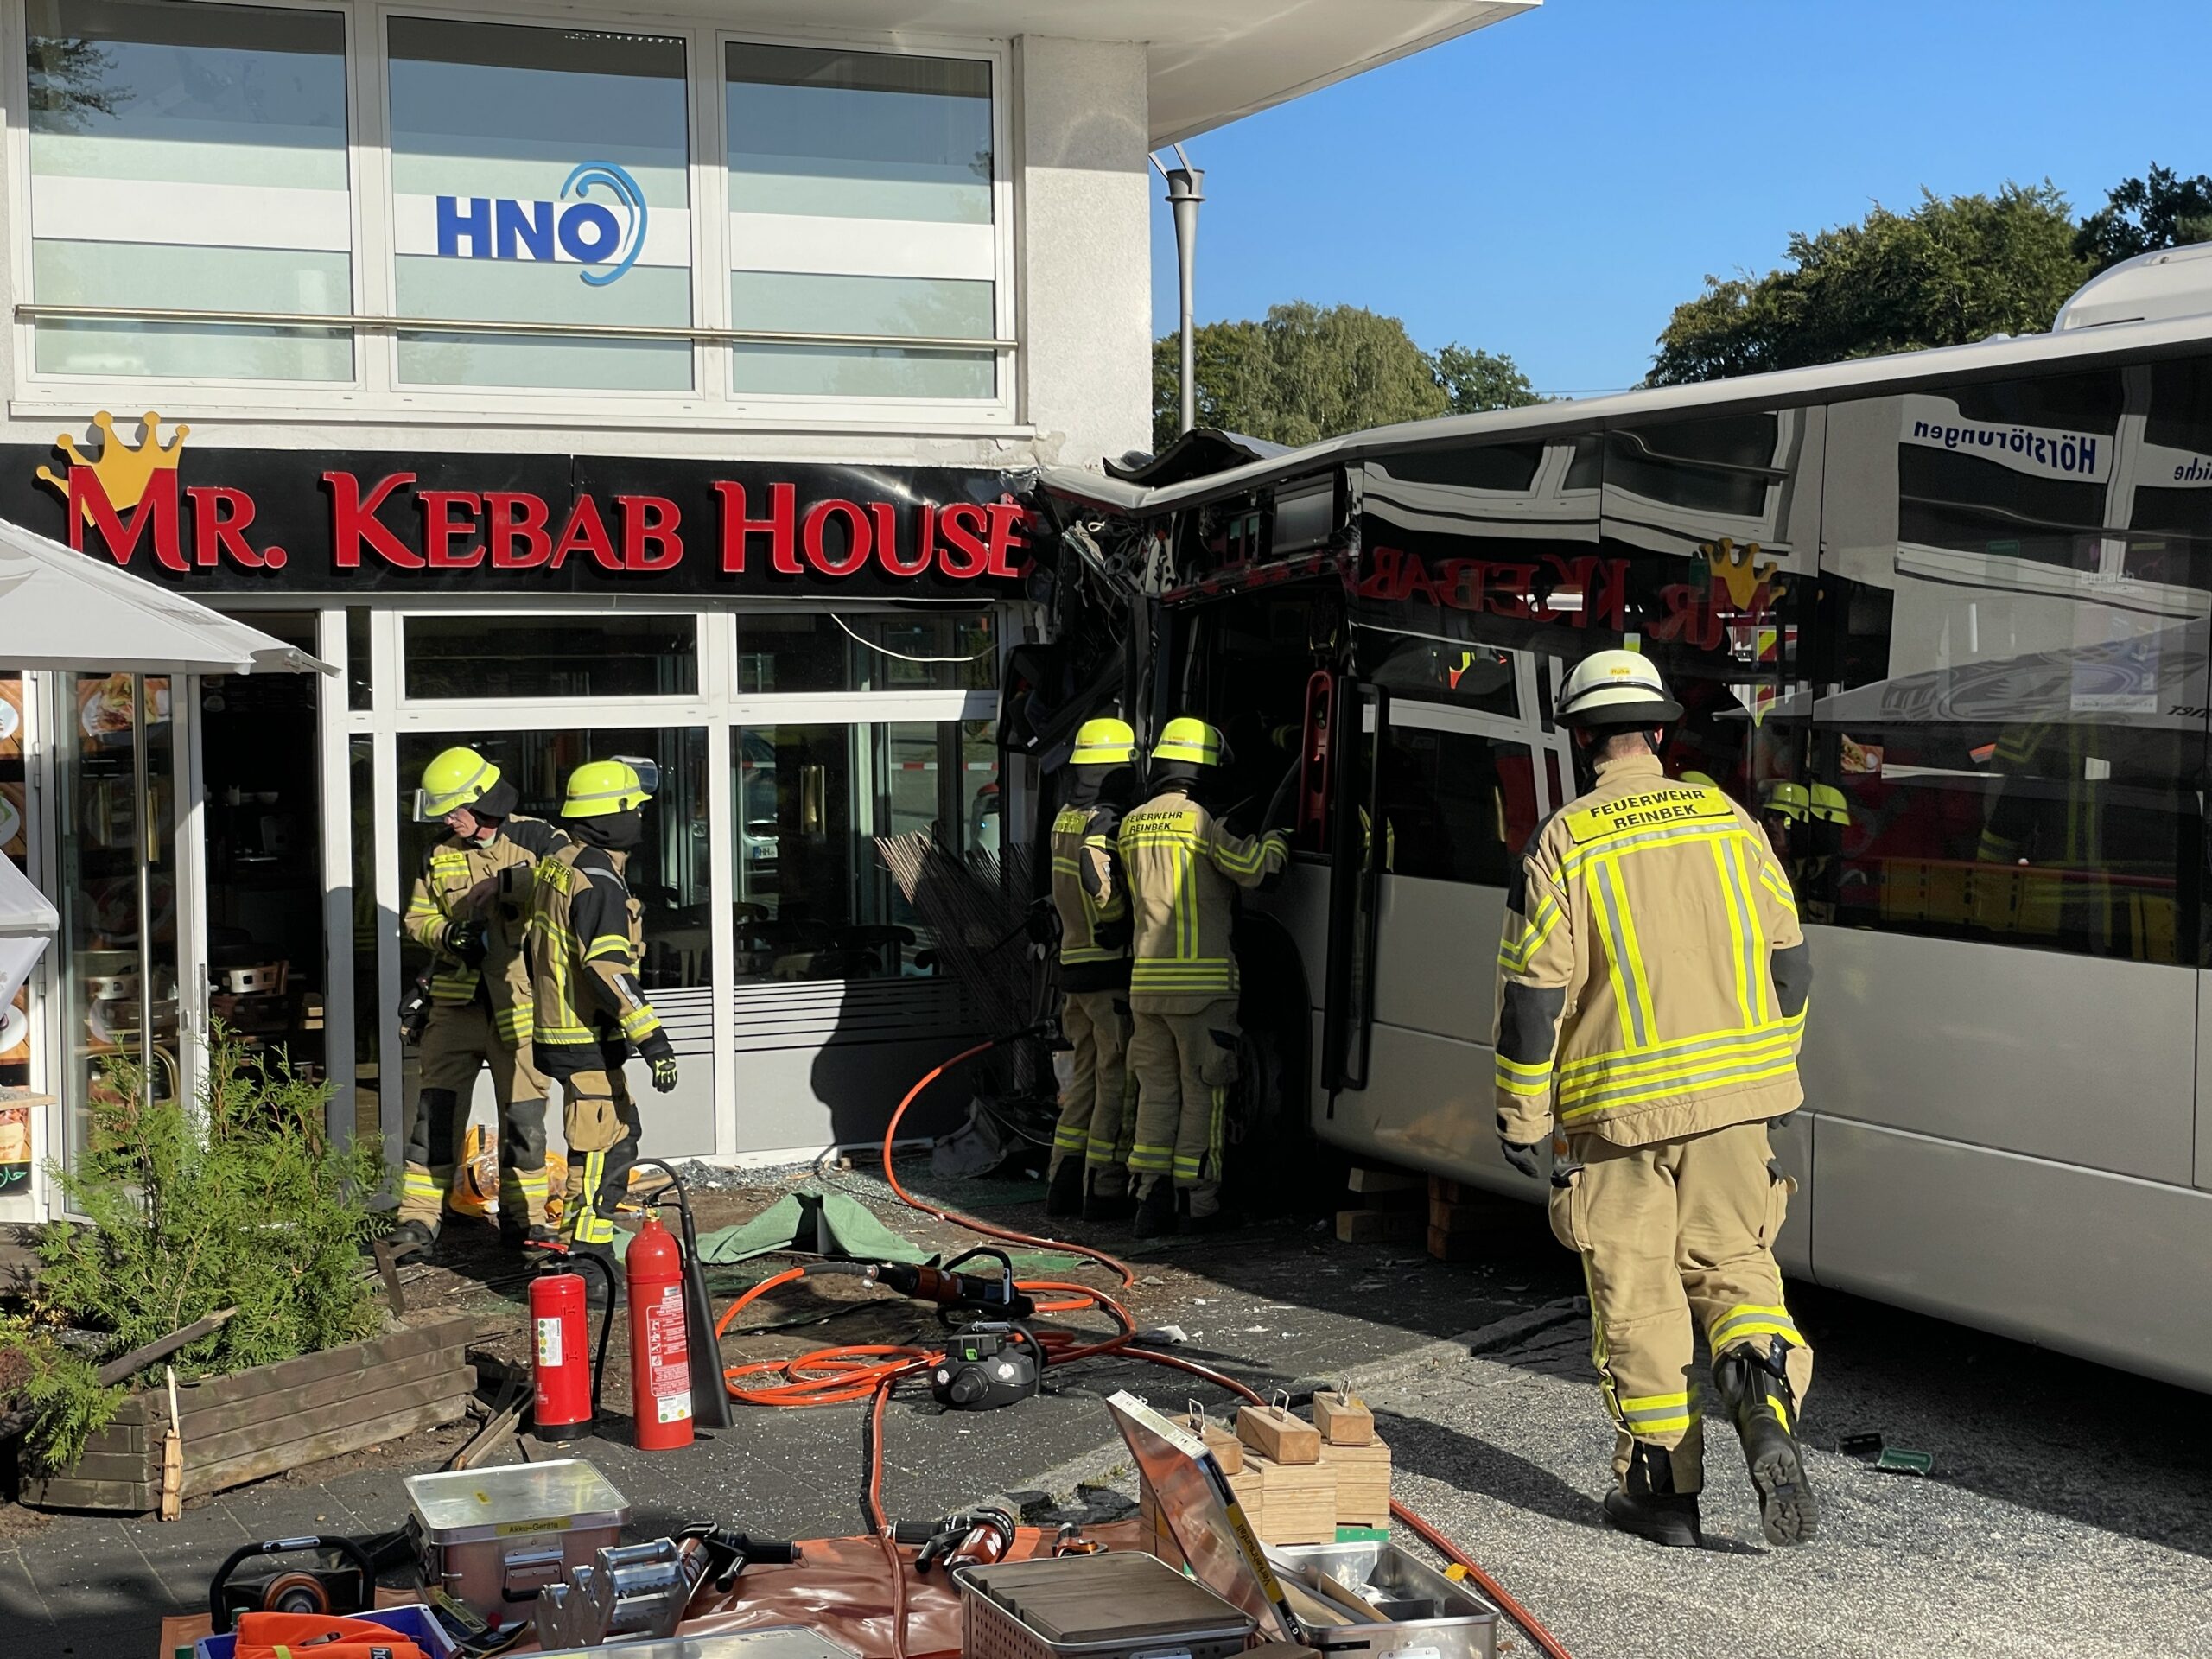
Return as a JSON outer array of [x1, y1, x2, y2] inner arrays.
[[0, 0, 1520, 1221]]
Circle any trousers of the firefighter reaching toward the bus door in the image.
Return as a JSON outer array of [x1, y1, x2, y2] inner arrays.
[[1128, 998, 1236, 1217]]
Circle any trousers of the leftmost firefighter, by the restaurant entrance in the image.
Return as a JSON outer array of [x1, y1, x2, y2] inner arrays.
[[400, 1002, 546, 1232]]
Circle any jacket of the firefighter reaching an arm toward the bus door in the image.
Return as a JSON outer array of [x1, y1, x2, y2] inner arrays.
[[1122, 785, 1289, 1013]]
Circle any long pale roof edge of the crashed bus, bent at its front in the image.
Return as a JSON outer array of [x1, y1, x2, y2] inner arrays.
[[1038, 315, 2212, 515]]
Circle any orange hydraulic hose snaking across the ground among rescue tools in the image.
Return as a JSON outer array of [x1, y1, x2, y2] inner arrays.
[[715, 1038, 1573, 1659]]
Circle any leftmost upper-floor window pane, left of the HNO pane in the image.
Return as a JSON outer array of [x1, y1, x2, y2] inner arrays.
[[27, 0, 354, 380]]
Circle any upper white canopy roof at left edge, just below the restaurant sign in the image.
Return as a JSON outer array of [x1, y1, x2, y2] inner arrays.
[[0, 520, 336, 675]]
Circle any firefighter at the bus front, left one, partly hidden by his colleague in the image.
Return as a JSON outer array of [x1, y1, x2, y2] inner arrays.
[[1044, 719, 1137, 1221]]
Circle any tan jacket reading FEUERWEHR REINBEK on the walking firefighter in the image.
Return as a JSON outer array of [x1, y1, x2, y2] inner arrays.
[[1497, 754, 1812, 1146]]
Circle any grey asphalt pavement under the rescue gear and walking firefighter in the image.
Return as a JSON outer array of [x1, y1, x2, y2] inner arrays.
[[0, 1177, 2212, 1659]]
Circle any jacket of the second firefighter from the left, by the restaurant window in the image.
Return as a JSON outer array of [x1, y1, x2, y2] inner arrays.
[[531, 842, 671, 1073]]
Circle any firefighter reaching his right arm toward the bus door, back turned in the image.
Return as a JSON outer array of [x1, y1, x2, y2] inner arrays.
[[1122, 716, 1289, 1239]]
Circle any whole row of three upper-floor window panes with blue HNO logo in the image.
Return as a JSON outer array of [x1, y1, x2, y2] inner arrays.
[[22, 0, 1011, 418]]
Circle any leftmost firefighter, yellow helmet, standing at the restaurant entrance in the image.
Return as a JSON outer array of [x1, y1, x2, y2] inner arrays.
[[391, 747, 566, 1255]]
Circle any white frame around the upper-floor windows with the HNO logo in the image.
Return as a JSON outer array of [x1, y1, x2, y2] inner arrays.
[[0, 0, 1028, 438]]
